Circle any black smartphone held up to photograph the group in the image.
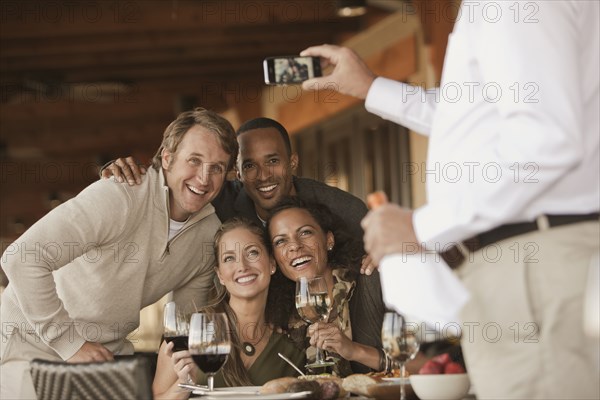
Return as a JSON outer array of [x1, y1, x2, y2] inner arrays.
[[263, 56, 323, 85]]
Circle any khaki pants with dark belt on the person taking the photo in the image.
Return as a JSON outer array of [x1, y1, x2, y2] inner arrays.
[[458, 222, 600, 399]]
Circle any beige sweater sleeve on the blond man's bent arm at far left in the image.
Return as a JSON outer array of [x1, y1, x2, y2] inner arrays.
[[2, 180, 130, 360]]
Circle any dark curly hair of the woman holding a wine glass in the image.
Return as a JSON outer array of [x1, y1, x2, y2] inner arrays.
[[265, 197, 363, 332]]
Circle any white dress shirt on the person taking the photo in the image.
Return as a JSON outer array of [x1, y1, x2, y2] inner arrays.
[[366, 0, 600, 250]]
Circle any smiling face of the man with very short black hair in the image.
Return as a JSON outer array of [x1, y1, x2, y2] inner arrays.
[[238, 128, 298, 219]]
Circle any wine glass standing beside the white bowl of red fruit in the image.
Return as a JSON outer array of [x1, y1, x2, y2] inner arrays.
[[381, 312, 419, 400]]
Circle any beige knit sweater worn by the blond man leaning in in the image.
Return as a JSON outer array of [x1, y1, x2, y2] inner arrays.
[[0, 169, 220, 360]]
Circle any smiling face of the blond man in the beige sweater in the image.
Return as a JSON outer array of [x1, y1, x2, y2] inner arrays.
[[162, 125, 230, 221]]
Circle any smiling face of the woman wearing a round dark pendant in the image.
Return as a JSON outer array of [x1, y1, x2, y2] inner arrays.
[[217, 227, 275, 299]]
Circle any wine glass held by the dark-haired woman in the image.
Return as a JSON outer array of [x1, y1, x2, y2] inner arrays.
[[296, 276, 334, 368]]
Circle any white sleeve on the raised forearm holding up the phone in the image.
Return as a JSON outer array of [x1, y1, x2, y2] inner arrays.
[[365, 77, 439, 136]]
